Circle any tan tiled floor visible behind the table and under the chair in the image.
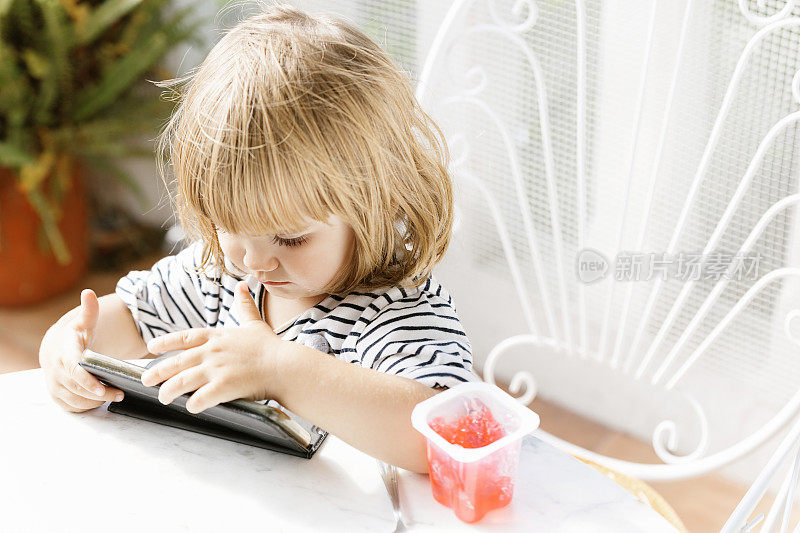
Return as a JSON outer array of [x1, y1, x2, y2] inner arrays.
[[0, 257, 788, 533]]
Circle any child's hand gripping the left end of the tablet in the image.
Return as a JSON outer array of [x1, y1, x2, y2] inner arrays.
[[39, 289, 123, 413]]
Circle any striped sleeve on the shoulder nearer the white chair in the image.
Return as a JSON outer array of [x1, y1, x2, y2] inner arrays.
[[355, 293, 481, 388]]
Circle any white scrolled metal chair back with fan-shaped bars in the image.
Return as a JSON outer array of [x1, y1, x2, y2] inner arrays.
[[417, 0, 800, 490]]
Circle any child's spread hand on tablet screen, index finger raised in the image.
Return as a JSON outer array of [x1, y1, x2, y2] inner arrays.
[[142, 282, 286, 413]]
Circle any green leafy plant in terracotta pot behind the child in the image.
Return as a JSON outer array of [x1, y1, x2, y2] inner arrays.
[[0, 0, 204, 306]]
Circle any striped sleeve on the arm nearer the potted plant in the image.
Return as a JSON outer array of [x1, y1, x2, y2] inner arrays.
[[115, 242, 208, 342]]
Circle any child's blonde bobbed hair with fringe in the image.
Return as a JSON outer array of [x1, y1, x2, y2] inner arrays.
[[157, 4, 453, 294]]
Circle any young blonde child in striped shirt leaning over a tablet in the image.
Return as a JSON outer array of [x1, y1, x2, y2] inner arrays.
[[40, 5, 480, 473]]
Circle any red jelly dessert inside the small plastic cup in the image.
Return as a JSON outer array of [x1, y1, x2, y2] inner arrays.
[[428, 404, 520, 522]]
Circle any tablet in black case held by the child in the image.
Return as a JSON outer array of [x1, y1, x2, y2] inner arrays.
[[79, 350, 328, 459]]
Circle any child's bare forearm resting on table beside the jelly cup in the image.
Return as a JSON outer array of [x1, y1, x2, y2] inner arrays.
[[272, 342, 440, 473]]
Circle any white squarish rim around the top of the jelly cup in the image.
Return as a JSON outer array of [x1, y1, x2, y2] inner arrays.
[[411, 382, 539, 463]]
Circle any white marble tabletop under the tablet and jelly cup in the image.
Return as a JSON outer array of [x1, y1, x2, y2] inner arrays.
[[0, 360, 675, 533]]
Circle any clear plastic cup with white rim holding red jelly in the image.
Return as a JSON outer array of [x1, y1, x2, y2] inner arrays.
[[411, 382, 539, 522]]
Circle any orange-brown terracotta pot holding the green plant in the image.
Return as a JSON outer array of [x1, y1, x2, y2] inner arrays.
[[0, 161, 89, 307]]
